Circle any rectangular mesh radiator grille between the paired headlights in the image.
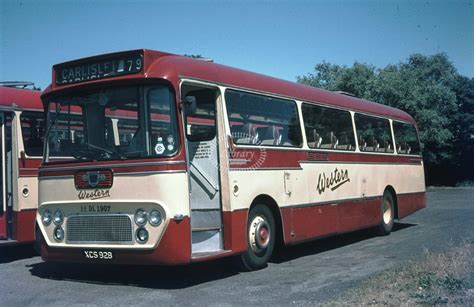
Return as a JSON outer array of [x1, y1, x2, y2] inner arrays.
[[66, 215, 132, 244]]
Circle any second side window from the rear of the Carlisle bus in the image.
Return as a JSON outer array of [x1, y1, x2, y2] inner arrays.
[[355, 114, 394, 153]]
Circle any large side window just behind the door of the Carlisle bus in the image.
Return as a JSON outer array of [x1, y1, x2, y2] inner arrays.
[[225, 90, 302, 147]]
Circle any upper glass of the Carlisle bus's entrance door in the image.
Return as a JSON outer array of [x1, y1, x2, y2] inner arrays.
[[186, 89, 217, 142]]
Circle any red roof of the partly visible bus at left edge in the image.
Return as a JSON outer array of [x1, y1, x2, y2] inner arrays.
[[0, 86, 43, 111]]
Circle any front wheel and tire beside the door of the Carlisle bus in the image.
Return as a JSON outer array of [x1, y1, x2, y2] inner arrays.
[[239, 204, 276, 271]]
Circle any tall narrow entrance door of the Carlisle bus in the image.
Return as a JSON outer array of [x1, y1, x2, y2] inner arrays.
[[181, 84, 223, 255]]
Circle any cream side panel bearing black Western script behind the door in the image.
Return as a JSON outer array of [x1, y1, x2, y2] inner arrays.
[[229, 162, 425, 210]]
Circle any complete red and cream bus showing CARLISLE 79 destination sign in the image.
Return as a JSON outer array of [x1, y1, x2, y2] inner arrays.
[[37, 50, 426, 270]]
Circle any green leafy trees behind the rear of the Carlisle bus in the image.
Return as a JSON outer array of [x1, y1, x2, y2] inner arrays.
[[297, 53, 474, 184]]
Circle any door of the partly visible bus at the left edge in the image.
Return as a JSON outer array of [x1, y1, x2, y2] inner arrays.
[[0, 112, 13, 240]]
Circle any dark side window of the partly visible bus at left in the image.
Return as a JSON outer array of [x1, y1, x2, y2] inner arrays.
[[20, 112, 45, 156]]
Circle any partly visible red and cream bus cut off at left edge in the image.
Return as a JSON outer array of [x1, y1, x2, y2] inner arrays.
[[0, 82, 45, 249]]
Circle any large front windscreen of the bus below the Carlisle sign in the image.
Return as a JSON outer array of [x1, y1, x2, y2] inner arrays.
[[45, 85, 178, 162]]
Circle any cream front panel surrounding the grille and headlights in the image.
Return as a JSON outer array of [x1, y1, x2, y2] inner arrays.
[[36, 172, 189, 249]]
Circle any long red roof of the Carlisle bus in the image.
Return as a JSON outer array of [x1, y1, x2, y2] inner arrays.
[[45, 49, 415, 123]]
